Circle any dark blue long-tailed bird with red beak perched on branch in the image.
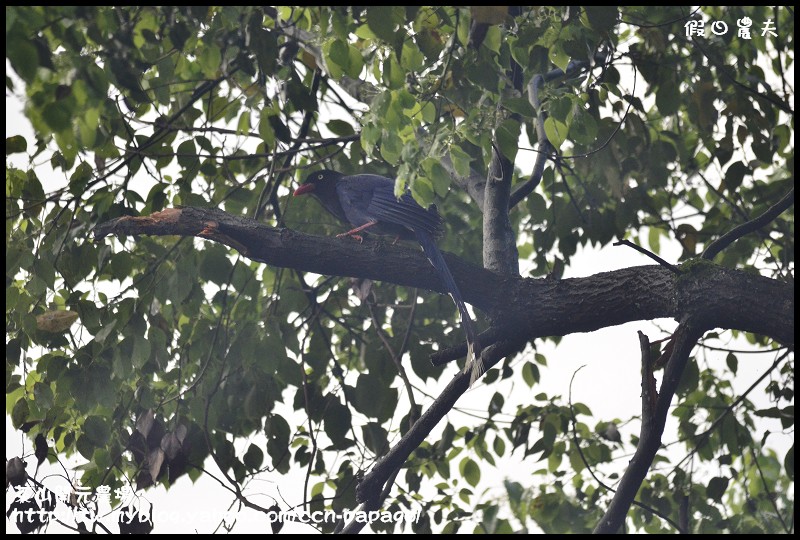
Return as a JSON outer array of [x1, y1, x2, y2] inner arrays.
[[294, 170, 483, 385]]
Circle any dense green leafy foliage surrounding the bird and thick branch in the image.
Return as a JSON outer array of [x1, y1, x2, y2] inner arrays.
[[6, 6, 794, 533]]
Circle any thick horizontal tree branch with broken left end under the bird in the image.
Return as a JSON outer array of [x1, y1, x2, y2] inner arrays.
[[94, 207, 794, 345]]
